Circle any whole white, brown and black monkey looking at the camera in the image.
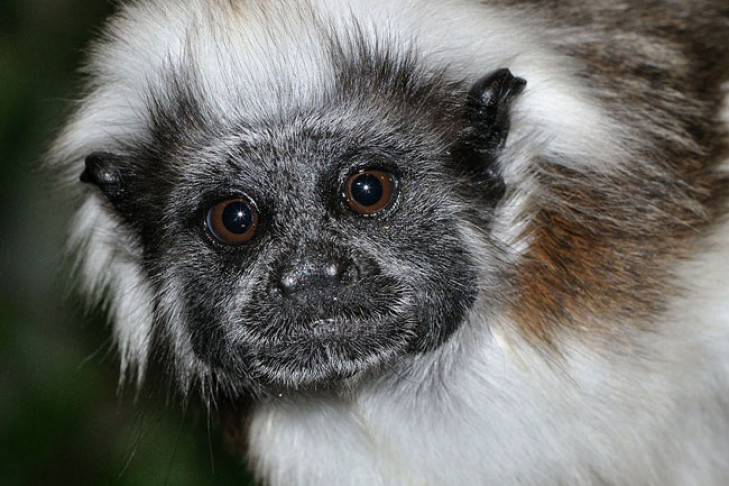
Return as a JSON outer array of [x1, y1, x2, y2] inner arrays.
[[54, 0, 729, 486]]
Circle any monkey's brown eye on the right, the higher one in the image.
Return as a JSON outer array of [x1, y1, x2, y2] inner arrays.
[[342, 169, 398, 215]]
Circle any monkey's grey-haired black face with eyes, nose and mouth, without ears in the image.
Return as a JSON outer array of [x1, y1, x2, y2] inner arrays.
[[164, 127, 476, 387]]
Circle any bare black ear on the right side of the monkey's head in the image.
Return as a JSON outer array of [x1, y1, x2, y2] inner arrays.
[[454, 68, 526, 197]]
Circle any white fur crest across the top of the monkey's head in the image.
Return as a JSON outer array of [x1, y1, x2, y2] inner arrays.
[[54, 0, 629, 178]]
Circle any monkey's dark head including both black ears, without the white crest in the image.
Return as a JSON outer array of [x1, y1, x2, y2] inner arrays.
[[81, 55, 525, 396]]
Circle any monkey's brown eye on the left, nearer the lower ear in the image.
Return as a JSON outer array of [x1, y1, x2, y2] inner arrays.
[[206, 198, 258, 245]]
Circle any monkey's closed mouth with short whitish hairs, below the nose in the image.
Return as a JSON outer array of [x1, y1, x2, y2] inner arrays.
[[210, 278, 424, 393]]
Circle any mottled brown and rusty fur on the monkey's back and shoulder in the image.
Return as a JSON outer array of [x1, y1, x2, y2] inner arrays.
[[501, 0, 729, 346]]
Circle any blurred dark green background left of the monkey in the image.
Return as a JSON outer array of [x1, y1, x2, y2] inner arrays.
[[0, 0, 250, 486]]
